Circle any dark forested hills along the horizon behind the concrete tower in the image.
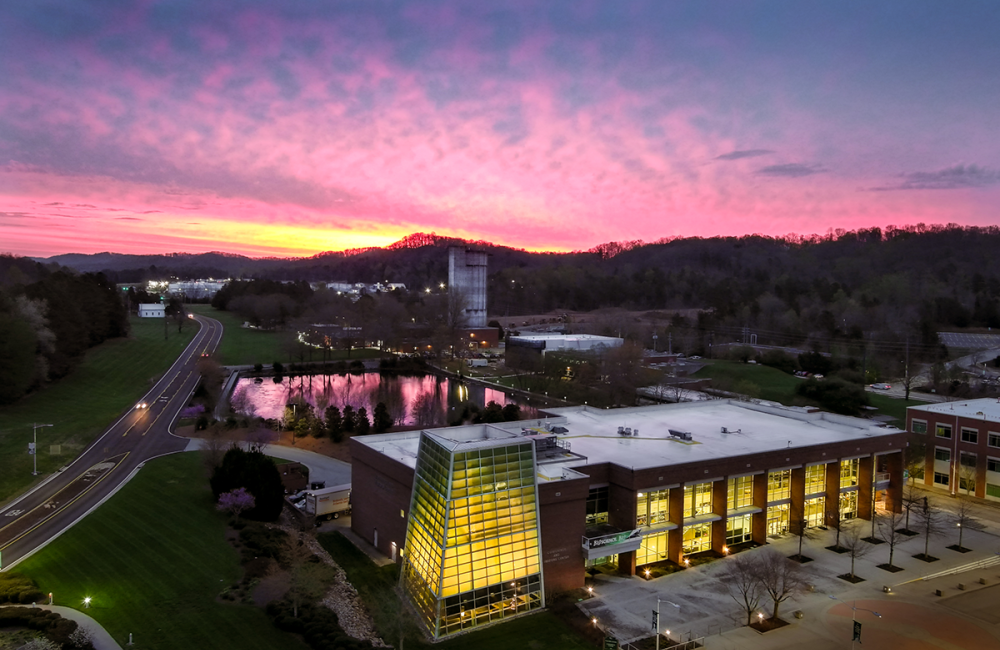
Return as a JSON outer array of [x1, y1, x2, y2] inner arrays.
[[37, 225, 1000, 332]]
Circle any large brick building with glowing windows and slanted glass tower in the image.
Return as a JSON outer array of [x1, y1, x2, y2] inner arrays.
[[351, 400, 907, 638]]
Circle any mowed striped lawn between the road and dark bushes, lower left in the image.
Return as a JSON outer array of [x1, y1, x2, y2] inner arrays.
[[15, 453, 305, 650]]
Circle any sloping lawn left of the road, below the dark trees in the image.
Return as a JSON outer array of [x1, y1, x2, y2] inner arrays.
[[0, 318, 197, 503]]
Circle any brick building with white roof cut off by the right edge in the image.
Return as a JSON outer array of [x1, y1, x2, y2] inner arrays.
[[906, 398, 1000, 501]]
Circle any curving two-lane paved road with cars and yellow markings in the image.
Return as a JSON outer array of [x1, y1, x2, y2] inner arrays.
[[0, 315, 222, 570]]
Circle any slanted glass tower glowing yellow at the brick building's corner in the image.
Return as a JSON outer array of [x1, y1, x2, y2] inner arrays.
[[403, 434, 544, 638]]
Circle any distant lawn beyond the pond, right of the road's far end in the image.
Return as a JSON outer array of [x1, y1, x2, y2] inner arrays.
[[188, 305, 381, 366]]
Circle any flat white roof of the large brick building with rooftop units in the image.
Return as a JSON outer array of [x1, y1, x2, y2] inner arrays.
[[354, 400, 900, 480]]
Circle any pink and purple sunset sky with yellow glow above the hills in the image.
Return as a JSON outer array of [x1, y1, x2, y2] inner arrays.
[[0, 0, 1000, 256]]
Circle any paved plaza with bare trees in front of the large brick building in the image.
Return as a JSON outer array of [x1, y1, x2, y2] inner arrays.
[[579, 492, 1000, 650]]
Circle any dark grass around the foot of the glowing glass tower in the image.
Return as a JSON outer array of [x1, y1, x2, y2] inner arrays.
[[319, 533, 593, 650]]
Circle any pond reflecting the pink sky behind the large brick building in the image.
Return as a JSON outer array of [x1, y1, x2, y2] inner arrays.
[[231, 372, 537, 427]]
